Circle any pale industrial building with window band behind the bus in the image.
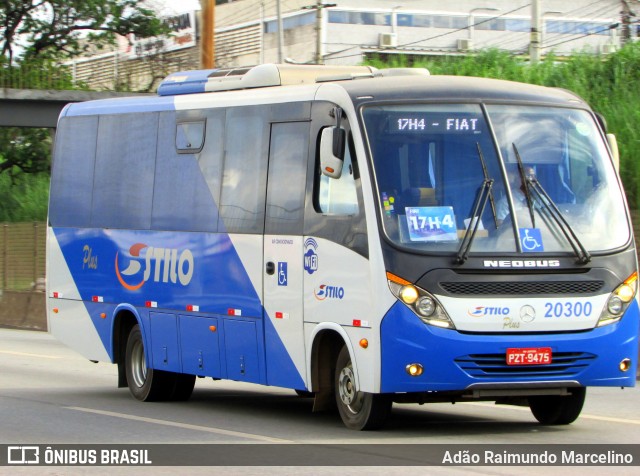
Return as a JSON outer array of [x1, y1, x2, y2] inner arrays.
[[69, 0, 640, 91]]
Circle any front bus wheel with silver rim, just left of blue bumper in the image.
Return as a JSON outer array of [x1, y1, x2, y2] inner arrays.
[[334, 346, 392, 430]]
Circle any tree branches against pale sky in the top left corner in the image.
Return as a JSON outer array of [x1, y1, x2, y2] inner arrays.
[[0, 0, 168, 63]]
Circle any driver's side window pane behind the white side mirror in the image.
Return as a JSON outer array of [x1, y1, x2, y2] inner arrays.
[[314, 130, 359, 215]]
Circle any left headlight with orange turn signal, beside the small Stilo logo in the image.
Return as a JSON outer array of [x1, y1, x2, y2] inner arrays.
[[387, 273, 456, 329]]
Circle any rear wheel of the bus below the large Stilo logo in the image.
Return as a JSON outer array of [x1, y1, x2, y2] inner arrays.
[[125, 324, 176, 402]]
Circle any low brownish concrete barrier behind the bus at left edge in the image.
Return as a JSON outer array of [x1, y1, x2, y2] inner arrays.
[[0, 291, 47, 331]]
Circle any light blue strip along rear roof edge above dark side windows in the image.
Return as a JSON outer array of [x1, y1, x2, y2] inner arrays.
[[63, 95, 175, 116]]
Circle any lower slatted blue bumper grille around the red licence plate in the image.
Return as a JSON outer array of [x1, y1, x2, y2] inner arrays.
[[455, 352, 596, 379]]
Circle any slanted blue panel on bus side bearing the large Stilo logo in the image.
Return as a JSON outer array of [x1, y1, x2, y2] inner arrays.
[[54, 228, 305, 389]]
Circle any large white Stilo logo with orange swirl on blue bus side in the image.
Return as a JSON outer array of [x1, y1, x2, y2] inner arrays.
[[115, 243, 194, 291]]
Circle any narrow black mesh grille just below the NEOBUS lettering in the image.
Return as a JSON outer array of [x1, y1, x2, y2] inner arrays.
[[440, 281, 604, 295]]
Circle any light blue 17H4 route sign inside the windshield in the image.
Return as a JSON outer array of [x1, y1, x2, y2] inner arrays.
[[405, 207, 458, 241]]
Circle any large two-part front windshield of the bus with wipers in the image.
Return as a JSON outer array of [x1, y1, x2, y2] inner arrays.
[[363, 104, 631, 255]]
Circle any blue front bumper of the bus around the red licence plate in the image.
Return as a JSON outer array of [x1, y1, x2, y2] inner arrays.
[[380, 300, 639, 393]]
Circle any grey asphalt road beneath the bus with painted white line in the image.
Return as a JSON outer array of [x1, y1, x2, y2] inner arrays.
[[0, 329, 640, 475]]
